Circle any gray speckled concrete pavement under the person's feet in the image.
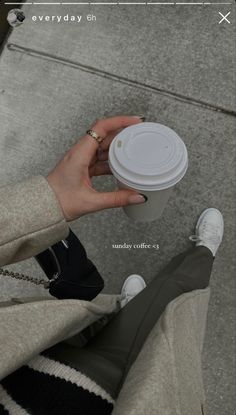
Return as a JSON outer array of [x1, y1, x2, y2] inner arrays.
[[0, 1, 236, 415]]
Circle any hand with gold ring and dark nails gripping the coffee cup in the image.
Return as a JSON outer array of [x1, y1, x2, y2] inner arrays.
[[47, 116, 145, 221]]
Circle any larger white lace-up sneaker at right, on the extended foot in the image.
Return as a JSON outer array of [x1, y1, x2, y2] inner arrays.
[[189, 208, 224, 256]]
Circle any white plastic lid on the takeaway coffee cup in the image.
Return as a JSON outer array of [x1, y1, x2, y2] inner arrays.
[[109, 122, 188, 191]]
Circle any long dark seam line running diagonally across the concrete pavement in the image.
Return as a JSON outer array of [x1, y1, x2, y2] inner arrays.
[[7, 43, 236, 117]]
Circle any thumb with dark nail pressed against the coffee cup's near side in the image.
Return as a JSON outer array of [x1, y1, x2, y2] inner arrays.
[[93, 190, 147, 209]]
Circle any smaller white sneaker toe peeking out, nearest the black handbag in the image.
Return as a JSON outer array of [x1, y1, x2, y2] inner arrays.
[[121, 274, 146, 308]]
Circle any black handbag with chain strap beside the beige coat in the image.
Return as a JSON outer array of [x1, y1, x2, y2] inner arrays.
[[0, 229, 104, 301]]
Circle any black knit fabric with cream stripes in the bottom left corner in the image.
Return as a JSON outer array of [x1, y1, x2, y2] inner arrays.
[[0, 355, 114, 415]]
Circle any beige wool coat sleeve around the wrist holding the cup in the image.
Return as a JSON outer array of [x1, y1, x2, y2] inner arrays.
[[0, 176, 69, 266]]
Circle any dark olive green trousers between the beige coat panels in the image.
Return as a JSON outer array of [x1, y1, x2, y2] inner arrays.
[[44, 246, 214, 398]]
